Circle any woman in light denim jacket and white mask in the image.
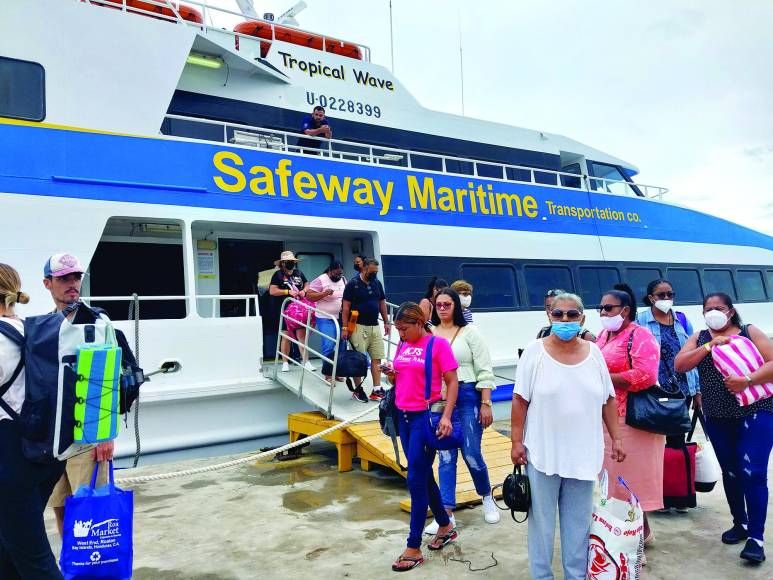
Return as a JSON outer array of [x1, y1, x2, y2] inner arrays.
[[636, 278, 701, 454]]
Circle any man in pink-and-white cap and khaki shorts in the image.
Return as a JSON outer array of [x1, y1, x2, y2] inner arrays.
[[43, 253, 114, 536]]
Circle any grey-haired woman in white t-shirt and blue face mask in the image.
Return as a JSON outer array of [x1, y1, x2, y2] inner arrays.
[[510, 294, 625, 580]]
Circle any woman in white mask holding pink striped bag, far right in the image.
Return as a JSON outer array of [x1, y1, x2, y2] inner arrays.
[[674, 292, 773, 563]]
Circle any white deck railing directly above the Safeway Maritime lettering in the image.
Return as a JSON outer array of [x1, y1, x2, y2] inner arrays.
[[165, 114, 668, 199]]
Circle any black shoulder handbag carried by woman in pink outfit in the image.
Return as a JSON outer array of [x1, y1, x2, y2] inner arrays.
[[625, 330, 691, 435]]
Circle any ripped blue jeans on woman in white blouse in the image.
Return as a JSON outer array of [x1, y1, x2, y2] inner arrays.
[[438, 383, 491, 509]]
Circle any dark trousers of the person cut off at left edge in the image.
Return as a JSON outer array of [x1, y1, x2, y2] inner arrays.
[[0, 420, 64, 580]]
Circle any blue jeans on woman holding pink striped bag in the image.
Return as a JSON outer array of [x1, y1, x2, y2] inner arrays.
[[706, 411, 773, 541]]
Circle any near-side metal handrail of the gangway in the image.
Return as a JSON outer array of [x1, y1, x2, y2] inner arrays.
[[273, 296, 341, 419]]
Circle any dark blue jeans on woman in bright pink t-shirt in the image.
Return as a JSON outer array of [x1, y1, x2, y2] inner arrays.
[[398, 411, 451, 549]]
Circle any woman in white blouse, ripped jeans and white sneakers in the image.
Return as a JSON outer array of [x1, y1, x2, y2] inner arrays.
[[424, 288, 499, 534]]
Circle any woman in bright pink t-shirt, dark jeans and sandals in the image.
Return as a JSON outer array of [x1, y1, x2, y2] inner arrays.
[[384, 302, 459, 572]]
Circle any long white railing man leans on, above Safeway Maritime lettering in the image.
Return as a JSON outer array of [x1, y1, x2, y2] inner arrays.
[[164, 114, 668, 199]]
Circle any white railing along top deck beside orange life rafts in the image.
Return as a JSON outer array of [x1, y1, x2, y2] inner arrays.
[[81, 0, 371, 62]]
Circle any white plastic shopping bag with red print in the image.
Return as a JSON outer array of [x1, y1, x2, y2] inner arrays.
[[587, 469, 644, 580]]
